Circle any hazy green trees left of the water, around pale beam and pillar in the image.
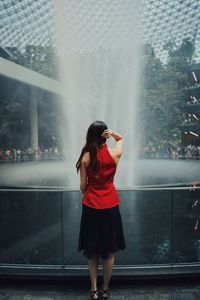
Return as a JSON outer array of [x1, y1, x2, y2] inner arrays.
[[0, 45, 58, 149]]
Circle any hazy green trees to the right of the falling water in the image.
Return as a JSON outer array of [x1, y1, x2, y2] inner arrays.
[[139, 39, 194, 143]]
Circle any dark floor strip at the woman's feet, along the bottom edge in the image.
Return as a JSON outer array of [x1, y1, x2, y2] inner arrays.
[[0, 278, 200, 300]]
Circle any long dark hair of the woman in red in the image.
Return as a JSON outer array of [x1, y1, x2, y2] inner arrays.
[[76, 121, 108, 175]]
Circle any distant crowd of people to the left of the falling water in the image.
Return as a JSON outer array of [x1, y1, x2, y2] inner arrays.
[[0, 147, 64, 162]]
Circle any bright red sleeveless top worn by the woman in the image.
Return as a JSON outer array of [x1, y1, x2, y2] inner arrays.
[[83, 144, 119, 209]]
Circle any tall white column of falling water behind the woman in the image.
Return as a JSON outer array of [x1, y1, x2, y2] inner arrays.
[[55, 0, 140, 187]]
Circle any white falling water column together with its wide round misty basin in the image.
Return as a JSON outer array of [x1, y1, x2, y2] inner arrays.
[[0, 0, 200, 189]]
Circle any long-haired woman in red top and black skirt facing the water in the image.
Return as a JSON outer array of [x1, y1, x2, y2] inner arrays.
[[76, 121, 126, 299]]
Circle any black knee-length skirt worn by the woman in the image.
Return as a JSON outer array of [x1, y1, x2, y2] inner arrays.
[[78, 205, 126, 259]]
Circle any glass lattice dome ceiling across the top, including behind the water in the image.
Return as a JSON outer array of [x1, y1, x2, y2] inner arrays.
[[0, 0, 200, 60]]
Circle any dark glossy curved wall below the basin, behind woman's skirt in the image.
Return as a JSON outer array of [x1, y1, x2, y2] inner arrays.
[[0, 190, 200, 274]]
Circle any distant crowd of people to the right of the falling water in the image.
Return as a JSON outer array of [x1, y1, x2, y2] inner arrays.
[[139, 142, 200, 160]]
